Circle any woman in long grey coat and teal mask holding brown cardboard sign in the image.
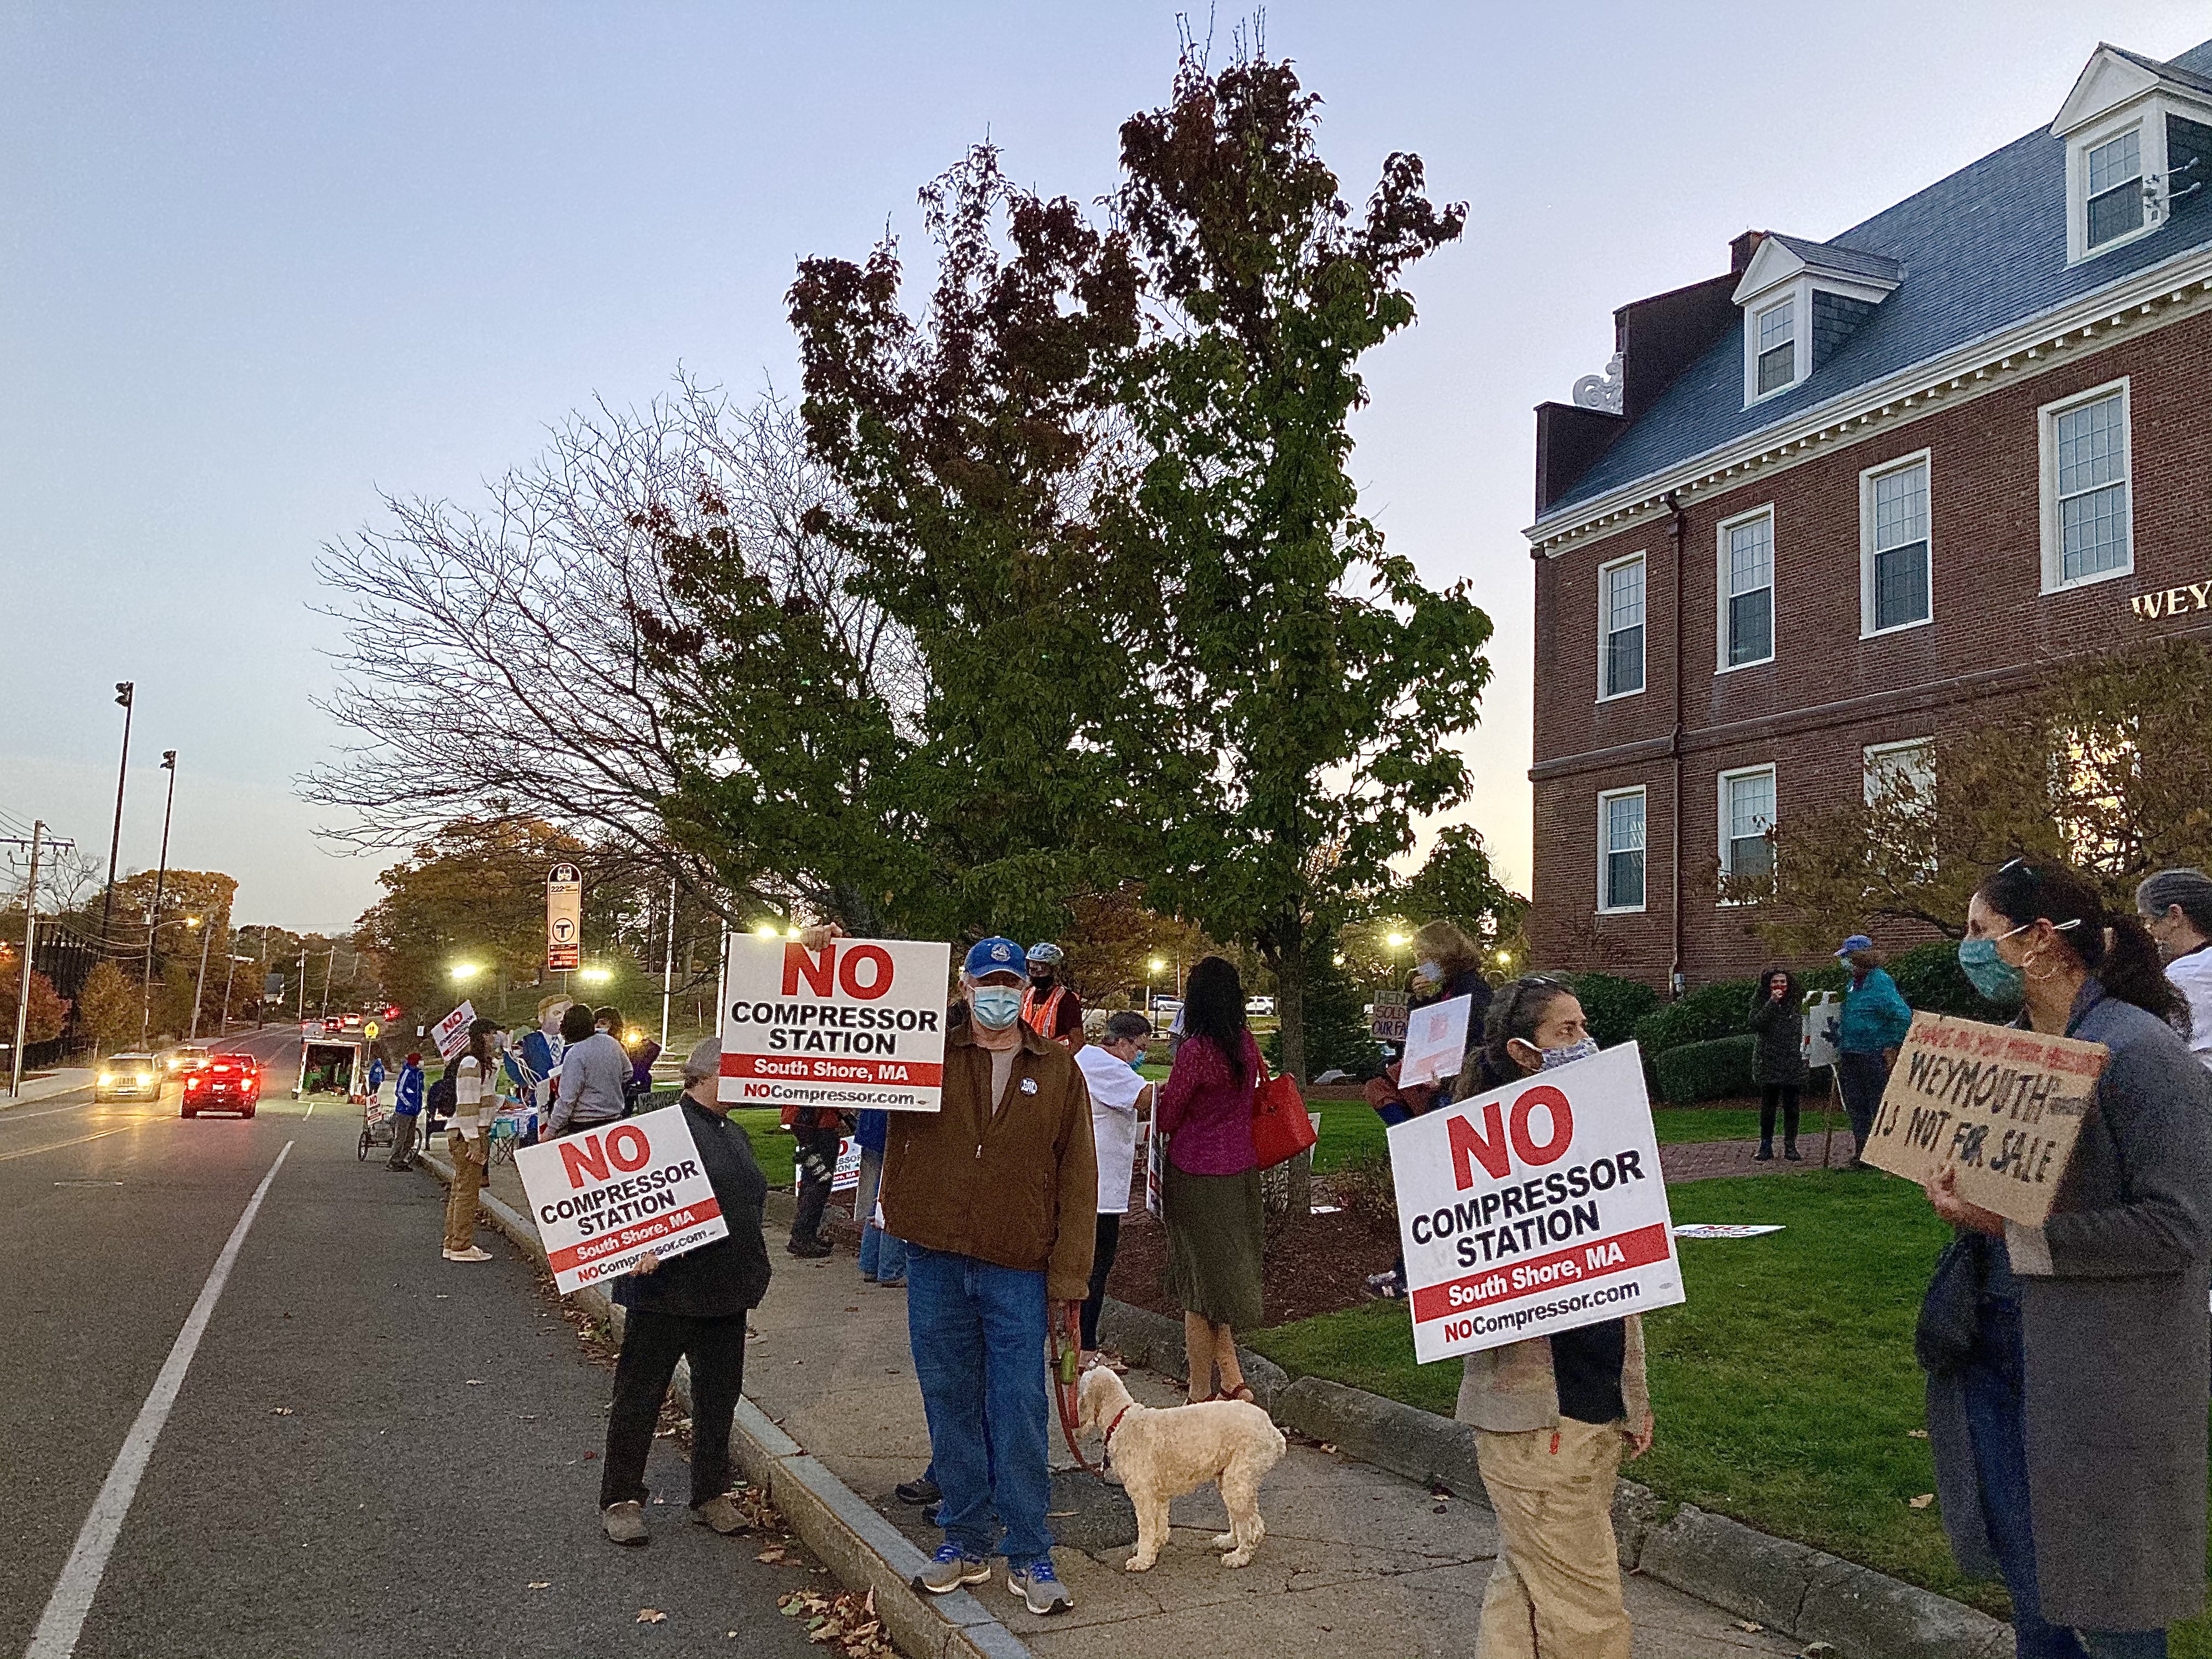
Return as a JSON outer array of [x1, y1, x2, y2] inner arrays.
[[1920, 858, 2212, 1659]]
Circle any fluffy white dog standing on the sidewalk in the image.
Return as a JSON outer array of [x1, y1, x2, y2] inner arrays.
[[1077, 1365, 1283, 1573]]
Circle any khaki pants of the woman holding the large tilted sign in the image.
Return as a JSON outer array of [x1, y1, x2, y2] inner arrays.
[[1475, 1418, 1628, 1659]]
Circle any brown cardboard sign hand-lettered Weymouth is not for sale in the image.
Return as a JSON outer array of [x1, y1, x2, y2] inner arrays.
[[1863, 1013, 2108, 1228]]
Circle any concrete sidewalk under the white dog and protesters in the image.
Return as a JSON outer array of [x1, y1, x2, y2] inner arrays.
[[746, 1229, 1798, 1659]]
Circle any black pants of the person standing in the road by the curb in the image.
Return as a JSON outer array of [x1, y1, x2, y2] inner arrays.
[[600, 1307, 746, 1509]]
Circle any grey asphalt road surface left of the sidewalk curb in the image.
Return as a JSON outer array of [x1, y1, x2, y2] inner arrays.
[[0, 1031, 834, 1659]]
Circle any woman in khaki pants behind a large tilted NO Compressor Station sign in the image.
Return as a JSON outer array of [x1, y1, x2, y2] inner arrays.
[[1442, 978, 1652, 1659]]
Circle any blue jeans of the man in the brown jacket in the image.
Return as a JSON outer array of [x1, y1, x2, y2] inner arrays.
[[907, 1245, 1053, 1566]]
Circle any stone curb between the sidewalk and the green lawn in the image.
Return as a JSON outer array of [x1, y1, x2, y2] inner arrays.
[[1099, 1299, 2013, 1659]]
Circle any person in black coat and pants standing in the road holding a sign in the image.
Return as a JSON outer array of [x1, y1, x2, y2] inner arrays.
[[600, 1037, 770, 1544]]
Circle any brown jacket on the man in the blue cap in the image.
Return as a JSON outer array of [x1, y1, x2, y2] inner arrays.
[[883, 1024, 1099, 1301]]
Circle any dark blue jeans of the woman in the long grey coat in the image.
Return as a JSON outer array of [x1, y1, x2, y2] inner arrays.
[[1966, 1305, 2165, 1659]]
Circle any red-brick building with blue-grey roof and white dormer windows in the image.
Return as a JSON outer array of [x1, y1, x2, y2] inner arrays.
[[1528, 42, 2212, 986]]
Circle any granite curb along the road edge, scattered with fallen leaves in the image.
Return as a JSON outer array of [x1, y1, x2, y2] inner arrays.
[[422, 1153, 1031, 1659]]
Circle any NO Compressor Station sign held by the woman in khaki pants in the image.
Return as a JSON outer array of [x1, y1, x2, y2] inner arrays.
[[1389, 1042, 1683, 1361]]
